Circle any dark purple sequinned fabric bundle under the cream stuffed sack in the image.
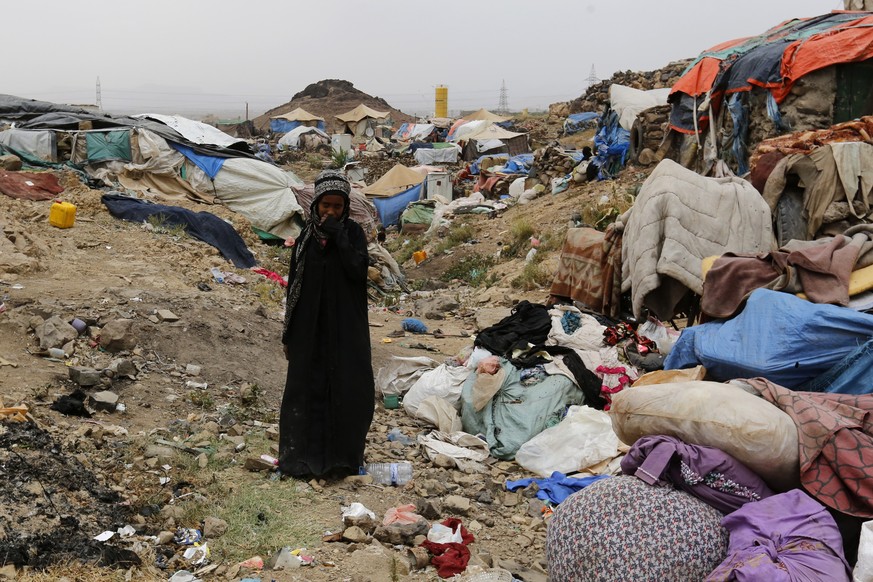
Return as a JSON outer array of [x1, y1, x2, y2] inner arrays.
[[621, 435, 775, 513]]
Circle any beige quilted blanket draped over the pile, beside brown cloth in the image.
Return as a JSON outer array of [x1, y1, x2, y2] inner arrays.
[[621, 159, 775, 320]]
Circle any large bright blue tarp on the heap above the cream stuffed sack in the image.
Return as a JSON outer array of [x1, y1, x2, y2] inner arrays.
[[664, 289, 873, 389]]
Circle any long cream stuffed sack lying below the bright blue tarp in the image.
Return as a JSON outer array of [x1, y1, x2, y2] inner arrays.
[[610, 382, 800, 491]]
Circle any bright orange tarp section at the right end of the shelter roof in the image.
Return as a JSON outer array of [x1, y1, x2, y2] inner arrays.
[[772, 13, 873, 103]]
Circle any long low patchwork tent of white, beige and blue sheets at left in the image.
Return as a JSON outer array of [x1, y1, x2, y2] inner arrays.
[[0, 99, 302, 238]]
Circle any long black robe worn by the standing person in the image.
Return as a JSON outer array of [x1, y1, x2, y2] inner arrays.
[[279, 219, 375, 477]]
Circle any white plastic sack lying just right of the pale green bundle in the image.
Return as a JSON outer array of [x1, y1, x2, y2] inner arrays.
[[515, 406, 620, 477]]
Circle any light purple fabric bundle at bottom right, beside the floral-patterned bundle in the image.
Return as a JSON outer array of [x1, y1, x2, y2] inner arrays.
[[706, 489, 851, 582]]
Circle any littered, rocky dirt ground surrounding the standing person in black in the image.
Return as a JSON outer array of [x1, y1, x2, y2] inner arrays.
[[0, 153, 645, 581]]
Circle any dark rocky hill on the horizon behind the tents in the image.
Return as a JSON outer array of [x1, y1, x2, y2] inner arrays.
[[254, 79, 414, 132]]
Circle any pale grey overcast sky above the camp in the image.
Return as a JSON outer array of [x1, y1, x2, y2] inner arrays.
[[0, 0, 842, 118]]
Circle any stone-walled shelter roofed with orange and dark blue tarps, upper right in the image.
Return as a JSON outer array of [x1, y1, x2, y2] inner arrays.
[[670, 11, 873, 173]]
